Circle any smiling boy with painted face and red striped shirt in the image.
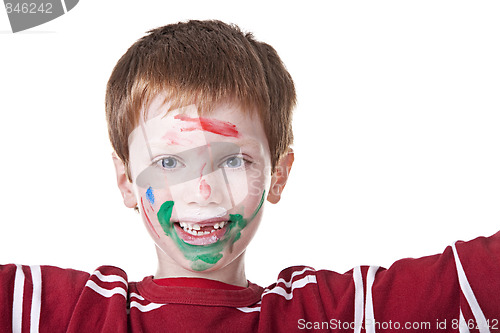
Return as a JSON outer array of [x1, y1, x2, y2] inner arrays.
[[0, 21, 500, 332]]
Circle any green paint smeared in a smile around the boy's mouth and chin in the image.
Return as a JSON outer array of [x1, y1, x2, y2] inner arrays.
[[157, 191, 266, 271]]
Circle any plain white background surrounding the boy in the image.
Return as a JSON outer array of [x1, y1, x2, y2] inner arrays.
[[0, 0, 500, 285]]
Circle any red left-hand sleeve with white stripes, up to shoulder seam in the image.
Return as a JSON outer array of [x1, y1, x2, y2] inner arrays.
[[0, 264, 128, 333]]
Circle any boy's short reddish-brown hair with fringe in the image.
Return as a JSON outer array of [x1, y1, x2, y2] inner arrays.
[[106, 21, 296, 176]]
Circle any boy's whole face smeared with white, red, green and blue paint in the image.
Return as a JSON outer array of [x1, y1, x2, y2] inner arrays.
[[129, 98, 271, 271]]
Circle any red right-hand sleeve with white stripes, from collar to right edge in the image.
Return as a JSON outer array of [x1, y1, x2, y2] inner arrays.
[[260, 233, 500, 333]]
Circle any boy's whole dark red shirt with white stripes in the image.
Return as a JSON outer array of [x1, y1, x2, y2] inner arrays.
[[0, 233, 500, 333]]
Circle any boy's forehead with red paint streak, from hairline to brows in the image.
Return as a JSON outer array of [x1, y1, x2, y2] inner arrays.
[[128, 96, 270, 167]]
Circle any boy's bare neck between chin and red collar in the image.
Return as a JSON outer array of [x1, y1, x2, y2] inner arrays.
[[154, 247, 248, 287]]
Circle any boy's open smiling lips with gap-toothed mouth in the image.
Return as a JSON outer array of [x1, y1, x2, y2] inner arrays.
[[173, 219, 231, 245]]
